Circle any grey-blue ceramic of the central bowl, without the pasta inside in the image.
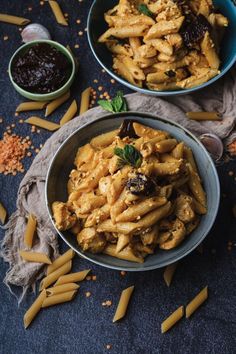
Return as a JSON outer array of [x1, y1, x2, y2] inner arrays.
[[45, 112, 220, 271]]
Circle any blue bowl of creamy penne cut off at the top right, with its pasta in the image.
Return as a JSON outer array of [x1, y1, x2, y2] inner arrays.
[[87, 0, 236, 96]]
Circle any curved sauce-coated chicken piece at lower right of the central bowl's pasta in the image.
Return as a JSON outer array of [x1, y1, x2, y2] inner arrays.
[[159, 219, 186, 250]]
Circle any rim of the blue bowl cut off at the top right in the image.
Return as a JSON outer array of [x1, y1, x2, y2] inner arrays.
[[87, 0, 236, 97]]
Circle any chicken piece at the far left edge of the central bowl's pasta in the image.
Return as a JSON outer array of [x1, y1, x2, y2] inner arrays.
[[52, 202, 77, 231]]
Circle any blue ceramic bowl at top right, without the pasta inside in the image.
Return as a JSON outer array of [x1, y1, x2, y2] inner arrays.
[[87, 0, 236, 96]]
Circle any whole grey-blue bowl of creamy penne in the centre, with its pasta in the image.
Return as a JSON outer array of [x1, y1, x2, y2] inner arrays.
[[46, 112, 220, 271]]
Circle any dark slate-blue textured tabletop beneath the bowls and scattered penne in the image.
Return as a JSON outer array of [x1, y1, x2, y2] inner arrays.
[[0, 0, 236, 354]]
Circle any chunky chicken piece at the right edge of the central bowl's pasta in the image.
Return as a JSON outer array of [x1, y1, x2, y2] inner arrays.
[[175, 194, 195, 223]]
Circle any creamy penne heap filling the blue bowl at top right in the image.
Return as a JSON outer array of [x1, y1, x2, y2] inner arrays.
[[98, 0, 228, 91]]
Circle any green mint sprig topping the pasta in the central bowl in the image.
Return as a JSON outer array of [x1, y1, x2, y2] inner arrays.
[[114, 145, 142, 168]]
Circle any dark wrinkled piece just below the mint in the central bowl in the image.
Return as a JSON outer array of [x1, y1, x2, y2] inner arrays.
[[126, 173, 156, 196]]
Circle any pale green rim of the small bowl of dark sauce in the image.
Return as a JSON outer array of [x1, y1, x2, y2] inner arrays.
[[8, 39, 75, 100]]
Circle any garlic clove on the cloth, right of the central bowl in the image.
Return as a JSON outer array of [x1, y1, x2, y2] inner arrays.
[[199, 133, 224, 161]]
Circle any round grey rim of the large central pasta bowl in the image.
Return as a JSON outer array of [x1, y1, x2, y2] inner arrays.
[[45, 111, 220, 272]]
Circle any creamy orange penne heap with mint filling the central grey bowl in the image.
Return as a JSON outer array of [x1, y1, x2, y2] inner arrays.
[[52, 120, 207, 262]]
